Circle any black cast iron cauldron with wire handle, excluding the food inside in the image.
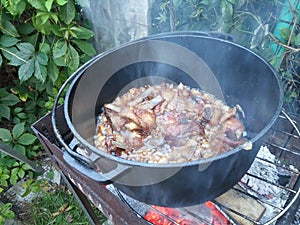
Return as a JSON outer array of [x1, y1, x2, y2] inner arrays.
[[52, 32, 283, 207]]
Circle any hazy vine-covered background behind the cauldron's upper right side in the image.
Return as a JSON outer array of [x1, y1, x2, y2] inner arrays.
[[151, 0, 300, 113]]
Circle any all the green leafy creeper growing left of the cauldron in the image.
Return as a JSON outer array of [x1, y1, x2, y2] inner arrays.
[[0, 0, 96, 222]]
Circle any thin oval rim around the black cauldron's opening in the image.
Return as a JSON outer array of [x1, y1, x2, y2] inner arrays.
[[64, 32, 283, 168]]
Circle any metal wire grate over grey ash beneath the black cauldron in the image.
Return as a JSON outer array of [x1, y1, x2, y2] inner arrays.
[[113, 111, 300, 225]]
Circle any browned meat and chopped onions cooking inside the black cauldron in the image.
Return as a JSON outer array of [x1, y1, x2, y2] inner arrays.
[[95, 83, 247, 163]]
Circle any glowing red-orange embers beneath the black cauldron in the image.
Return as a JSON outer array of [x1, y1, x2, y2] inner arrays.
[[145, 202, 231, 225]]
